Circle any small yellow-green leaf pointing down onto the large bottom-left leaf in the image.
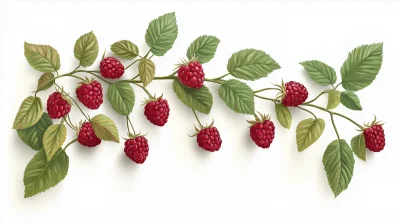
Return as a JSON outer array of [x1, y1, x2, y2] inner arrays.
[[43, 124, 67, 161]]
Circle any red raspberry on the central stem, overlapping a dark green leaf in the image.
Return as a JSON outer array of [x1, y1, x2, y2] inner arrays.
[[178, 61, 204, 89]]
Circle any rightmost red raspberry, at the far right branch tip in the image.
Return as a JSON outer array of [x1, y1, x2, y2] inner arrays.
[[364, 125, 385, 152]]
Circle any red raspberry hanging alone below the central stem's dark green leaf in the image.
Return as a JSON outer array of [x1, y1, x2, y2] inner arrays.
[[197, 127, 222, 152]]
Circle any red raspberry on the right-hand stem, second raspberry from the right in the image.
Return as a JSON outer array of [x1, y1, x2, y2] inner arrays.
[[282, 81, 308, 107]]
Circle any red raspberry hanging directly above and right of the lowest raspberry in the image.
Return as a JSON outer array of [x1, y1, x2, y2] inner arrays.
[[144, 97, 169, 127]]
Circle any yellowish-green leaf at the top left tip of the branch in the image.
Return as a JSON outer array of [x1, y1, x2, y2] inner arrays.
[[24, 42, 60, 72]]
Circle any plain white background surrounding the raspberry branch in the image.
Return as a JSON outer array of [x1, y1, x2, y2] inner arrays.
[[0, 1, 400, 224]]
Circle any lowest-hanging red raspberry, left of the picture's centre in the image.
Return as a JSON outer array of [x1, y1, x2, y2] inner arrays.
[[124, 136, 149, 164]]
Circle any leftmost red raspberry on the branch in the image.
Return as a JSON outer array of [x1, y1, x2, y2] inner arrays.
[[47, 92, 71, 119]]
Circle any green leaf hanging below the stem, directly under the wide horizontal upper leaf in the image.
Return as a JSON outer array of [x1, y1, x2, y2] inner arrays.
[[218, 79, 254, 114]]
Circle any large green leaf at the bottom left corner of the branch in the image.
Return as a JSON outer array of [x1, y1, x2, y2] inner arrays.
[[24, 149, 69, 198]]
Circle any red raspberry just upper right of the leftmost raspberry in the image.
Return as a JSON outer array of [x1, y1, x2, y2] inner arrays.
[[76, 80, 103, 110]]
